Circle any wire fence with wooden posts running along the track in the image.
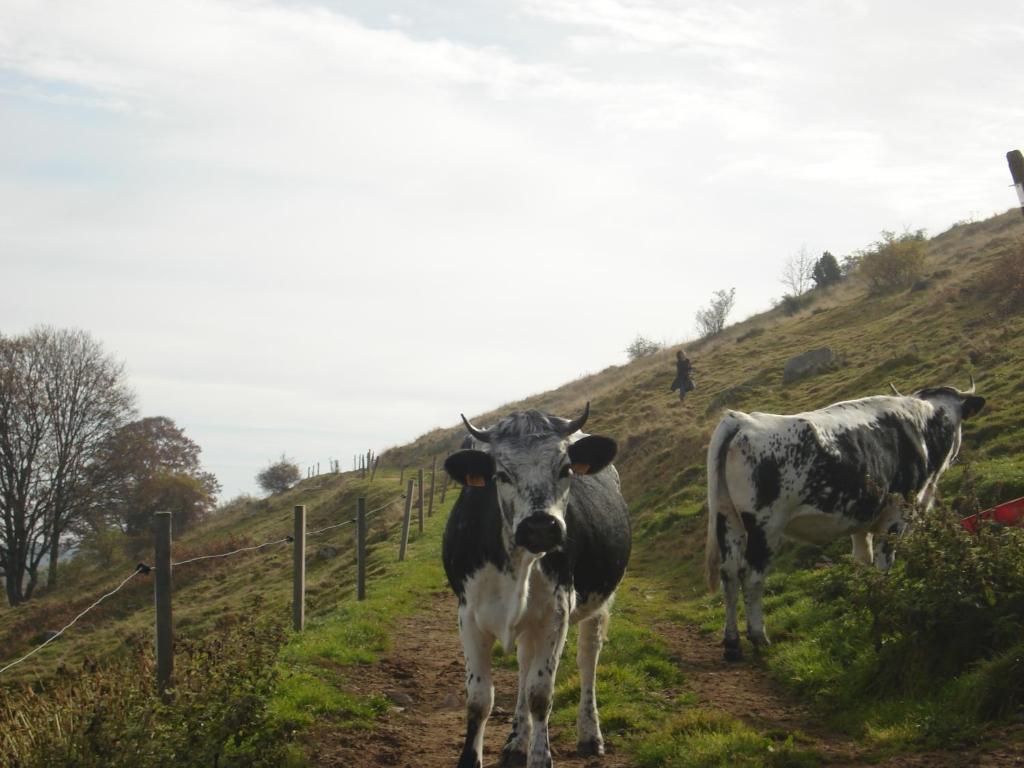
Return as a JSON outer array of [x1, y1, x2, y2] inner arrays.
[[0, 462, 434, 692]]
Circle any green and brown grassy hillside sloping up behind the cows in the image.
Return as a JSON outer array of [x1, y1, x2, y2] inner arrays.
[[0, 211, 1024, 766]]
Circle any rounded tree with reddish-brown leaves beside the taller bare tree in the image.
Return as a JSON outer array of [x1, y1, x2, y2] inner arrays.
[[89, 416, 220, 536]]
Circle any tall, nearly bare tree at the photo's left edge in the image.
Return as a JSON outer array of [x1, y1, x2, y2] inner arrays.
[[0, 327, 134, 605]]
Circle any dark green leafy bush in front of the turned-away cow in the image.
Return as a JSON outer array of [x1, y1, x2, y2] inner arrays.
[[776, 504, 1024, 742]]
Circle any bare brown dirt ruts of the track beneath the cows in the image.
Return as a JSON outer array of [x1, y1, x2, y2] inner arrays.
[[310, 592, 1024, 768]]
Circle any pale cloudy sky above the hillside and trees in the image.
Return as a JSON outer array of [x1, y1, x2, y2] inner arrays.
[[0, 0, 1024, 500]]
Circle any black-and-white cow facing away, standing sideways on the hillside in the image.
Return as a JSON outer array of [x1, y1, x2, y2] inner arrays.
[[706, 379, 985, 660]]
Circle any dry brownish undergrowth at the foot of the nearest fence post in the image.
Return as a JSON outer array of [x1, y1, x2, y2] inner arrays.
[[0, 603, 286, 768]]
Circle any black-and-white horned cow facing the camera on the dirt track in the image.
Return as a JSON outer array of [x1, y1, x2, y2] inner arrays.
[[442, 403, 631, 768]]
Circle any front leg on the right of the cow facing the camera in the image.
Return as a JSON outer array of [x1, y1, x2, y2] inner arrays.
[[524, 587, 569, 768]]
